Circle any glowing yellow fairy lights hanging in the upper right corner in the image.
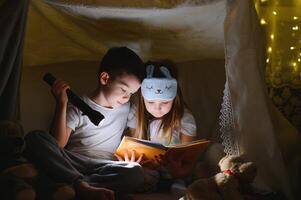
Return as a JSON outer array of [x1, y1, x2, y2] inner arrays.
[[255, 0, 301, 88]]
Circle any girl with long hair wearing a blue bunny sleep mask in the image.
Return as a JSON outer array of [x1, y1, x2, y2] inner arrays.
[[126, 61, 196, 188]]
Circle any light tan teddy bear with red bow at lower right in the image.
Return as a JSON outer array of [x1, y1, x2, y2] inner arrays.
[[182, 155, 257, 200]]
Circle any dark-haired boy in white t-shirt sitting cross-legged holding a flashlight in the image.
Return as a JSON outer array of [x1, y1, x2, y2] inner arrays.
[[26, 47, 145, 199]]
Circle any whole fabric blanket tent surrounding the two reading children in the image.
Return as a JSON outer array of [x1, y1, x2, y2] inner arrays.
[[17, 0, 300, 199]]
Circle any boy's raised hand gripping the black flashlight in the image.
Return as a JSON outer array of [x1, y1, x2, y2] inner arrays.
[[51, 79, 70, 104]]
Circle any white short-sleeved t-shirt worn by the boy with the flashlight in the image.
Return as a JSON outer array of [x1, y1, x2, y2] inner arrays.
[[66, 96, 130, 160]]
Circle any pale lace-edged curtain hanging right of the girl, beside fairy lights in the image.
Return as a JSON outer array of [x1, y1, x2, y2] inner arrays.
[[221, 0, 293, 199]]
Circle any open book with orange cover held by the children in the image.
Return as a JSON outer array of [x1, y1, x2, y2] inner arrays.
[[116, 136, 210, 159]]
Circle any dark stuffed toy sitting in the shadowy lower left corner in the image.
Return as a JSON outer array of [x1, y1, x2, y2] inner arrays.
[[0, 120, 75, 200]]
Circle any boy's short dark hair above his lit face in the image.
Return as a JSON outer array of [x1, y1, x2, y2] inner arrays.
[[98, 47, 145, 82]]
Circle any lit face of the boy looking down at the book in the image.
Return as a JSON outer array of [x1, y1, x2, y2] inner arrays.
[[103, 73, 141, 108]]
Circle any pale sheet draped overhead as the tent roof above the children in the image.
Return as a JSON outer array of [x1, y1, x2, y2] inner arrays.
[[25, 0, 226, 66]]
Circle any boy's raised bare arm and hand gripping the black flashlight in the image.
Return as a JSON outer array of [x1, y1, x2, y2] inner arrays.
[[51, 80, 72, 148]]
